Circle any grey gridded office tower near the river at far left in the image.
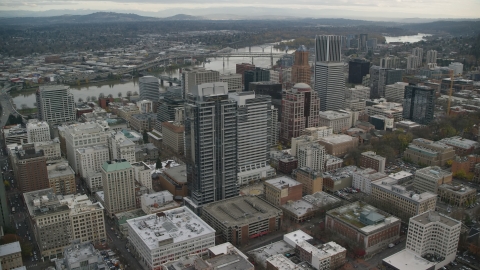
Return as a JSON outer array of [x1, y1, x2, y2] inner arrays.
[[37, 85, 77, 124]]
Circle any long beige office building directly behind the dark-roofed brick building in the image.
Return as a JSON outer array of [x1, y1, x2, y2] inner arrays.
[[371, 176, 437, 218]]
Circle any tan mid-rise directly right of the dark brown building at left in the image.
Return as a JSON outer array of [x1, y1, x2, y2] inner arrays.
[[47, 160, 77, 195]]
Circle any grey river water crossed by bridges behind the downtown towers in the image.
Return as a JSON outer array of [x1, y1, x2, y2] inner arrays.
[[10, 44, 293, 108]]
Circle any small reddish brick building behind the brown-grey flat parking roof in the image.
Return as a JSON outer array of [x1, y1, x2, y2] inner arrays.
[[263, 176, 302, 206]]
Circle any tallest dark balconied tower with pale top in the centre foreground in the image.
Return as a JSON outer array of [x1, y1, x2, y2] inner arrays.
[[185, 82, 238, 212]]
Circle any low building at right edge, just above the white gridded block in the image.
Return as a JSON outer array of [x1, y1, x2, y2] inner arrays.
[[438, 183, 477, 207]]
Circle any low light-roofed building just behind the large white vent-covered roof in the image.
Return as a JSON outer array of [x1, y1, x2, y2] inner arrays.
[[140, 190, 180, 215]]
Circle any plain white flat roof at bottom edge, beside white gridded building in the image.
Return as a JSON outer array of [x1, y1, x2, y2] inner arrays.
[[383, 249, 436, 270]]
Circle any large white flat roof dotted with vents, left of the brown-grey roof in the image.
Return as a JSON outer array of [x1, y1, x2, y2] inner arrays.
[[127, 206, 215, 250]]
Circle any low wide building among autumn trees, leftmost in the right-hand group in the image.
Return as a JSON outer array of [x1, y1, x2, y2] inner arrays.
[[403, 138, 455, 166]]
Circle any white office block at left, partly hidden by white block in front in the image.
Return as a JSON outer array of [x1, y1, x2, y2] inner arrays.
[[64, 121, 109, 173]]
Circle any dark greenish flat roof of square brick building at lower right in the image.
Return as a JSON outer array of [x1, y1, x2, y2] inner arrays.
[[327, 201, 399, 234]]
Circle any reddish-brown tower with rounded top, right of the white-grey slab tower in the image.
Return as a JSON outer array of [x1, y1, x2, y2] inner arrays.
[[280, 83, 320, 144]]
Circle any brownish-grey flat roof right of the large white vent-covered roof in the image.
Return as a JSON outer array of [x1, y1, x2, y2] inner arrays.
[[203, 195, 282, 227]]
